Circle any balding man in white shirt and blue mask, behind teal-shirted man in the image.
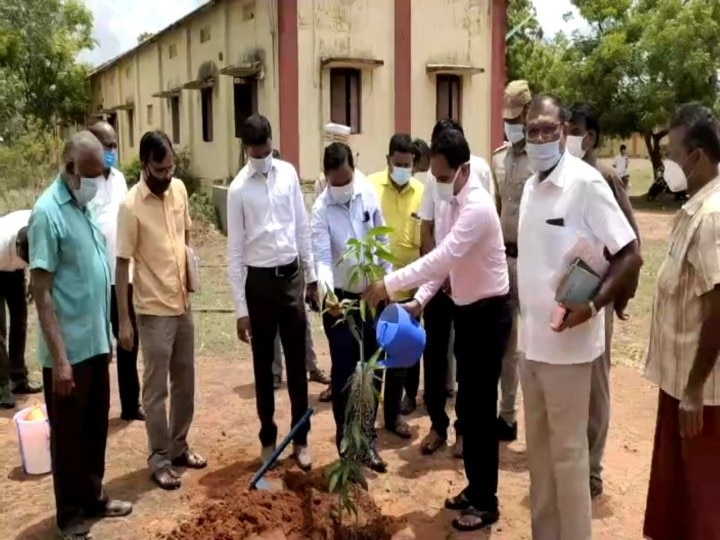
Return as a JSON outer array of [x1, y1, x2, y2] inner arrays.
[[88, 121, 145, 422]]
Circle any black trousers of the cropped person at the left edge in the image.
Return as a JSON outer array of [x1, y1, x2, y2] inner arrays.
[[0, 270, 27, 386]]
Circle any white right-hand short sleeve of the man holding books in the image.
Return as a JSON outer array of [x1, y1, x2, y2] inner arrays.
[[582, 178, 637, 255]]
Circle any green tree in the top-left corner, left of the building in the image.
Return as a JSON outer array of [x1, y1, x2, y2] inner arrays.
[[0, 0, 95, 140]]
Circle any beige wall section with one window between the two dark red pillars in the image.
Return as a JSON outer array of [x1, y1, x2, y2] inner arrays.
[[300, 0, 395, 179]]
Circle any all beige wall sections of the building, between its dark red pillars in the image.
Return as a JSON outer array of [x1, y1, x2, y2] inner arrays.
[[91, 0, 492, 184]]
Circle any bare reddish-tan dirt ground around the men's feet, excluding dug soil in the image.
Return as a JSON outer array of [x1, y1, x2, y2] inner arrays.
[[0, 213, 670, 540]]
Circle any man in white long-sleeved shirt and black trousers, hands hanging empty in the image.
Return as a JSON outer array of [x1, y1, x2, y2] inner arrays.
[[227, 114, 318, 470]]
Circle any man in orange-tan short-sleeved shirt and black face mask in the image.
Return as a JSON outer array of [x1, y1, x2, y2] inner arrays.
[[115, 131, 206, 489]]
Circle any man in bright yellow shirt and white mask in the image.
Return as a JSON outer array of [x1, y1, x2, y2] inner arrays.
[[368, 133, 424, 439]]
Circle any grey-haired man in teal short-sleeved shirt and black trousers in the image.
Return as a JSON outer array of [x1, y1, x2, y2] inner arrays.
[[28, 131, 132, 540]]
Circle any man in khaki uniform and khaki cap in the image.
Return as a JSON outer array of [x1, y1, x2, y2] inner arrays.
[[493, 81, 532, 441]]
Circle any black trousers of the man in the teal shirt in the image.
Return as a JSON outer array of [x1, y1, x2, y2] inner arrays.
[[43, 354, 110, 530]]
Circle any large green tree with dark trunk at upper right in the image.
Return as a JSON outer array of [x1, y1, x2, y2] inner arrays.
[[562, 0, 720, 168]]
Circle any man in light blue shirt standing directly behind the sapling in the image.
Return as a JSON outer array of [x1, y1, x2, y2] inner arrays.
[[312, 143, 391, 472]]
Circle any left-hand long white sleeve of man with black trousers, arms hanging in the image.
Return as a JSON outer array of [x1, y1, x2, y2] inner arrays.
[[227, 186, 248, 319]]
